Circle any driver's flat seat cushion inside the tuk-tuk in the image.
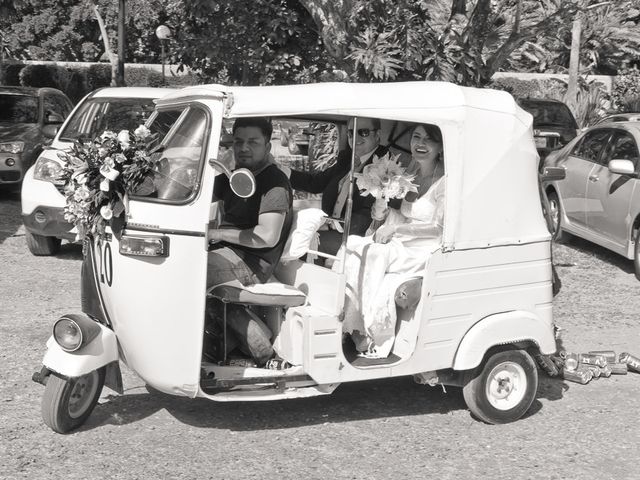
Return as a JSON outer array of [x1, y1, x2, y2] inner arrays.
[[207, 282, 307, 307]]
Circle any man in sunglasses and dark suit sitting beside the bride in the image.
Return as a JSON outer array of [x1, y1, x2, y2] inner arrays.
[[283, 118, 387, 255]]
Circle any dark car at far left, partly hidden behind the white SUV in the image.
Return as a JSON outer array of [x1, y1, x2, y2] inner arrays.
[[0, 87, 73, 187]]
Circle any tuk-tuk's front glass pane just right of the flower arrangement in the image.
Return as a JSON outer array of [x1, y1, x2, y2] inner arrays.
[[135, 107, 207, 202]]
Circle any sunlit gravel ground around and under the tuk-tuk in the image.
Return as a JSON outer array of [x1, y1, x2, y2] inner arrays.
[[0, 188, 640, 480]]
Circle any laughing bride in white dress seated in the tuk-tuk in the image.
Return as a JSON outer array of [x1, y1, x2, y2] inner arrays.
[[334, 125, 444, 358]]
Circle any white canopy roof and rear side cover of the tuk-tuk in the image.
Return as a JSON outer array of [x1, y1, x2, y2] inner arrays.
[[158, 81, 549, 249]]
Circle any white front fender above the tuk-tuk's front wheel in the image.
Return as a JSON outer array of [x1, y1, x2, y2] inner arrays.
[[42, 323, 119, 377]]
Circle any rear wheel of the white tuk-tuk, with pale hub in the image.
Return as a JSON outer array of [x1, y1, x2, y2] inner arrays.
[[462, 349, 538, 424]]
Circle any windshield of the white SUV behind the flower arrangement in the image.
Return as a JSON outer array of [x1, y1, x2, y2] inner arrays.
[[60, 98, 154, 142]]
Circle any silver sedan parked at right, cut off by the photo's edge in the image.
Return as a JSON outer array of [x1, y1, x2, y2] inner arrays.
[[545, 121, 640, 279]]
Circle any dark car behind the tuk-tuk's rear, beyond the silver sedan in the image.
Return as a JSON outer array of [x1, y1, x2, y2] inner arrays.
[[518, 98, 578, 162]]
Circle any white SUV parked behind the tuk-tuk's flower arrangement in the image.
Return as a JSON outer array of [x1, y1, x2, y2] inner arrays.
[[22, 87, 175, 255]]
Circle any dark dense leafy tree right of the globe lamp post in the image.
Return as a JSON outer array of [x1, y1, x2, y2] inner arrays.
[[167, 0, 330, 85]]
